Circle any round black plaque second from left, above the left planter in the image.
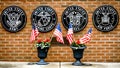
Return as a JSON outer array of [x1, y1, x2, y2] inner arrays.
[[31, 6, 57, 32]]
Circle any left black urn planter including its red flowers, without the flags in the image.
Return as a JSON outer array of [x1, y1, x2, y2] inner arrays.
[[36, 39, 50, 65]]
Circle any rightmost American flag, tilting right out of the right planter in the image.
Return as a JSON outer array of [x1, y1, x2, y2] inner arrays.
[[79, 28, 92, 44]]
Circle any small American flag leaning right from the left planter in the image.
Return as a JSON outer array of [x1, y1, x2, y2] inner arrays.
[[54, 24, 64, 44]]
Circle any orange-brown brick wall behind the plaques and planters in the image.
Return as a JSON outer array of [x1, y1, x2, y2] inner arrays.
[[0, 0, 120, 62]]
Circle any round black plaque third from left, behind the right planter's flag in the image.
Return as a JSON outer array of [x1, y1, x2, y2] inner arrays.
[[62, 5, 88, 32]]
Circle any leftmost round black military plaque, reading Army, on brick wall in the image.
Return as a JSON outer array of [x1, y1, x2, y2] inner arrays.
[[1, 6, 27, 32]]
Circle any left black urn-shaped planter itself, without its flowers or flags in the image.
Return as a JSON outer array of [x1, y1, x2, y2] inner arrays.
[[37, 46, 49, 65]]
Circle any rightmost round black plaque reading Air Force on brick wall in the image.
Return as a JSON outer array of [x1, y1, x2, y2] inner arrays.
[[93, 5, 119, 32]]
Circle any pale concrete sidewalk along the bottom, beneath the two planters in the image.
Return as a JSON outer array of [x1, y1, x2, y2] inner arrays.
[[0, 61, 120, 68]]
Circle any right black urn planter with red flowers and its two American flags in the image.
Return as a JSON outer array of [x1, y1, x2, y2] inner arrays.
[[66, 23, 92, 66]]
